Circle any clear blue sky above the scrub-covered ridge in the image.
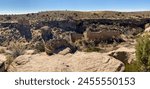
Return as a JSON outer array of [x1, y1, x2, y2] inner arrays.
[[0, 0, 150, 14]]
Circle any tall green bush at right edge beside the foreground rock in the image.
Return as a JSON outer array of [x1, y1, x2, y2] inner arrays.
[[136, 34, 150, 72]]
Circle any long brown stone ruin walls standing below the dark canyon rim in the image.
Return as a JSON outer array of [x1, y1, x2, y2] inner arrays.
[[69, 29, 121, 43]]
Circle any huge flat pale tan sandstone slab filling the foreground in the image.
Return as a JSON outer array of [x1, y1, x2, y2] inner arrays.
[[7, 52, 125, 72]]
